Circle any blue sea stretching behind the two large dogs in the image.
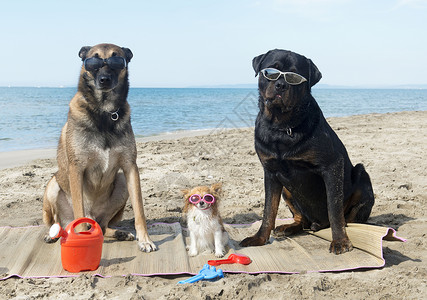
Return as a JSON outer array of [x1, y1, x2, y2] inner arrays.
[[0, 87, 427, 152]]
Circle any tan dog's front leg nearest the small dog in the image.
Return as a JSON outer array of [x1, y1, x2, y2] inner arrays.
[[124, 164, 157, 252]]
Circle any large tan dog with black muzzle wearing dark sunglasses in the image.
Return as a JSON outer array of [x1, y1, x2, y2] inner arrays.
[[43, 44, 156, 252]]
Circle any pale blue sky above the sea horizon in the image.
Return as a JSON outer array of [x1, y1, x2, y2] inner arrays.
[[0, 0, 427, 87]]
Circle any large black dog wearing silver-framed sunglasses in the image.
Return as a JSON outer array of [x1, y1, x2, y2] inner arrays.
[[240, 49, 374, 254]]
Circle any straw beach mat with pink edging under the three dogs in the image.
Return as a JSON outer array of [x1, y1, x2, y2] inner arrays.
[[0, 220, 405, 279]]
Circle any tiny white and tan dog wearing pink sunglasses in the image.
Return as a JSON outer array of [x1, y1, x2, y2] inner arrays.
[[182, 183, 228, 257]]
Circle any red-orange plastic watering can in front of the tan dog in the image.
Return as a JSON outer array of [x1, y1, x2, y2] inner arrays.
[[49, 218, 104, 273]]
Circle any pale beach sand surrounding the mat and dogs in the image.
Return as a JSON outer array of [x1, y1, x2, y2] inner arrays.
[[0, 111, 427, 299]]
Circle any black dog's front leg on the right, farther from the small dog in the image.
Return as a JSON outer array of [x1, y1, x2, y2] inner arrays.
[[323, 157, 353, 254]]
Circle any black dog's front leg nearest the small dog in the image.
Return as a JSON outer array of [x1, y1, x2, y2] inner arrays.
[[240, 169, 283, 247]]
